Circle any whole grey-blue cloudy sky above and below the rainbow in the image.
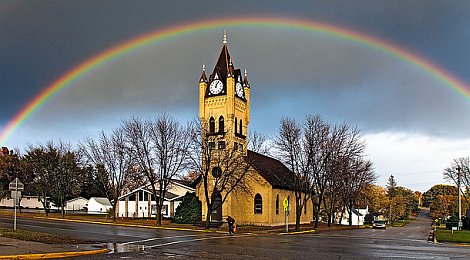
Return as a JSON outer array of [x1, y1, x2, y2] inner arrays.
[[0, 0, 470, 191]]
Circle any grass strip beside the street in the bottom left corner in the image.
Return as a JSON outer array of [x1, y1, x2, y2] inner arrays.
[[0, 227, 89, 244]]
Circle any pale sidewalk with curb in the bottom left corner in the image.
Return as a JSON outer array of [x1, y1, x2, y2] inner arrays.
[[0, 237, 106, 259]]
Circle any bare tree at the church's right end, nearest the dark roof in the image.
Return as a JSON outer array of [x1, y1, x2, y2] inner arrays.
[[275, 118, 312, 230]]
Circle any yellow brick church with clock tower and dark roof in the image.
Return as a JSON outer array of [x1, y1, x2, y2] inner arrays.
[[196, 33, 313, 226]]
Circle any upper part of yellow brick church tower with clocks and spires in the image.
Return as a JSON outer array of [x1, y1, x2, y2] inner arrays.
[[199, 32, 250, 153]]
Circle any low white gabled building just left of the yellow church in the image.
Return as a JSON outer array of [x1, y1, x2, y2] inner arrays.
[[116, 181, 194, 218]]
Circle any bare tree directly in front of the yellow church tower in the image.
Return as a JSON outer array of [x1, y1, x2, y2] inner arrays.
[[189, 119, 250, 228]]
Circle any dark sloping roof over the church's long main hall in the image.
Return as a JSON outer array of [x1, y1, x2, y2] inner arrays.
[[247, 150, 294, 190]]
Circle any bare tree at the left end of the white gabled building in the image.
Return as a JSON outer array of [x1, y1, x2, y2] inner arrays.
[[80, 128, 135, 222]]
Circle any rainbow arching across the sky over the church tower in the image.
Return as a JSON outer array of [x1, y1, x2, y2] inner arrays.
[[0, 17, 470, 145]]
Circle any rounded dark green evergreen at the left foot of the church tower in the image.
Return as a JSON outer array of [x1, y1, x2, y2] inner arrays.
[[173, 192, 202, 224]]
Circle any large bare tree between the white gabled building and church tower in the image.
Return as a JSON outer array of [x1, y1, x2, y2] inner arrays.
[[123, 114, 190, 226]]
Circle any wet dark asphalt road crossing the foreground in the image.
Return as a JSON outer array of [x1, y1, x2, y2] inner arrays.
[[0, 211, 470, 259]]
